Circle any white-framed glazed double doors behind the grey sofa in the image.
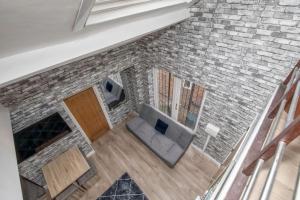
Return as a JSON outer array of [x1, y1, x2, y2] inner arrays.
[[154, 69, 205, 130]]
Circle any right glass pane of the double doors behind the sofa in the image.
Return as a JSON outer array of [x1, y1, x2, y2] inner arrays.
[[178, 81, 204, 129]]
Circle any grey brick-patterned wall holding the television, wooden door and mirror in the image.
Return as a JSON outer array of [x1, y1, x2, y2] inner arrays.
[[0, 43, 149, 184]]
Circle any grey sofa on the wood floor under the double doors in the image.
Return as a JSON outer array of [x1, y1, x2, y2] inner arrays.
[[127, 104, 194, 167]]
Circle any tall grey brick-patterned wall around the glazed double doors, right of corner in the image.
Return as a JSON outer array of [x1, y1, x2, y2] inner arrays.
[[140, 0, 300, 162]]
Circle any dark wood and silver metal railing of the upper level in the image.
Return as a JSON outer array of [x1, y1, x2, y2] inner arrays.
[[241, 62, 300, 200]]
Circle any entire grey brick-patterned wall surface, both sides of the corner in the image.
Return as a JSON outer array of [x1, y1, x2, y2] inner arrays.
[[0, 0, 300, 175]]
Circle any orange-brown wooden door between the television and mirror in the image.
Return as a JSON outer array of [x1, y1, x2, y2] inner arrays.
[[64, 88, 109, 141]]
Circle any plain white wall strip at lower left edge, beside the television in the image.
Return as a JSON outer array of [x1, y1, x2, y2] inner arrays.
[[0, 104, 23, 200]]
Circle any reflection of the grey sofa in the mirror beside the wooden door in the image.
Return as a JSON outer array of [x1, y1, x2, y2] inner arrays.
[[101, 78, 125, 109]]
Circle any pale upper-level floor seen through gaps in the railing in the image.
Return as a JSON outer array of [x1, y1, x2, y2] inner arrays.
[[250, 113, 300, 200]]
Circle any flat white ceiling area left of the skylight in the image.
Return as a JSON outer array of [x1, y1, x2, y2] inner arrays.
[[0, 0, 81, 58]]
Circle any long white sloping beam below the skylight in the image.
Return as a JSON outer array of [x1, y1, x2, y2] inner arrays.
[[0, 5, 190, 87]]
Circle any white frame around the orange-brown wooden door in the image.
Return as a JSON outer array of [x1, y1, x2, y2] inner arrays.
[[62, 86, 113, 145]]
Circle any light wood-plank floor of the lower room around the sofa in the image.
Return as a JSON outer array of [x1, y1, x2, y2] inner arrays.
[[70, 115, 218, 200]]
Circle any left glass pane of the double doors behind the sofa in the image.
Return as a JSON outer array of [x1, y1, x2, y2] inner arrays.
[[158, 69, 174, 116]]
